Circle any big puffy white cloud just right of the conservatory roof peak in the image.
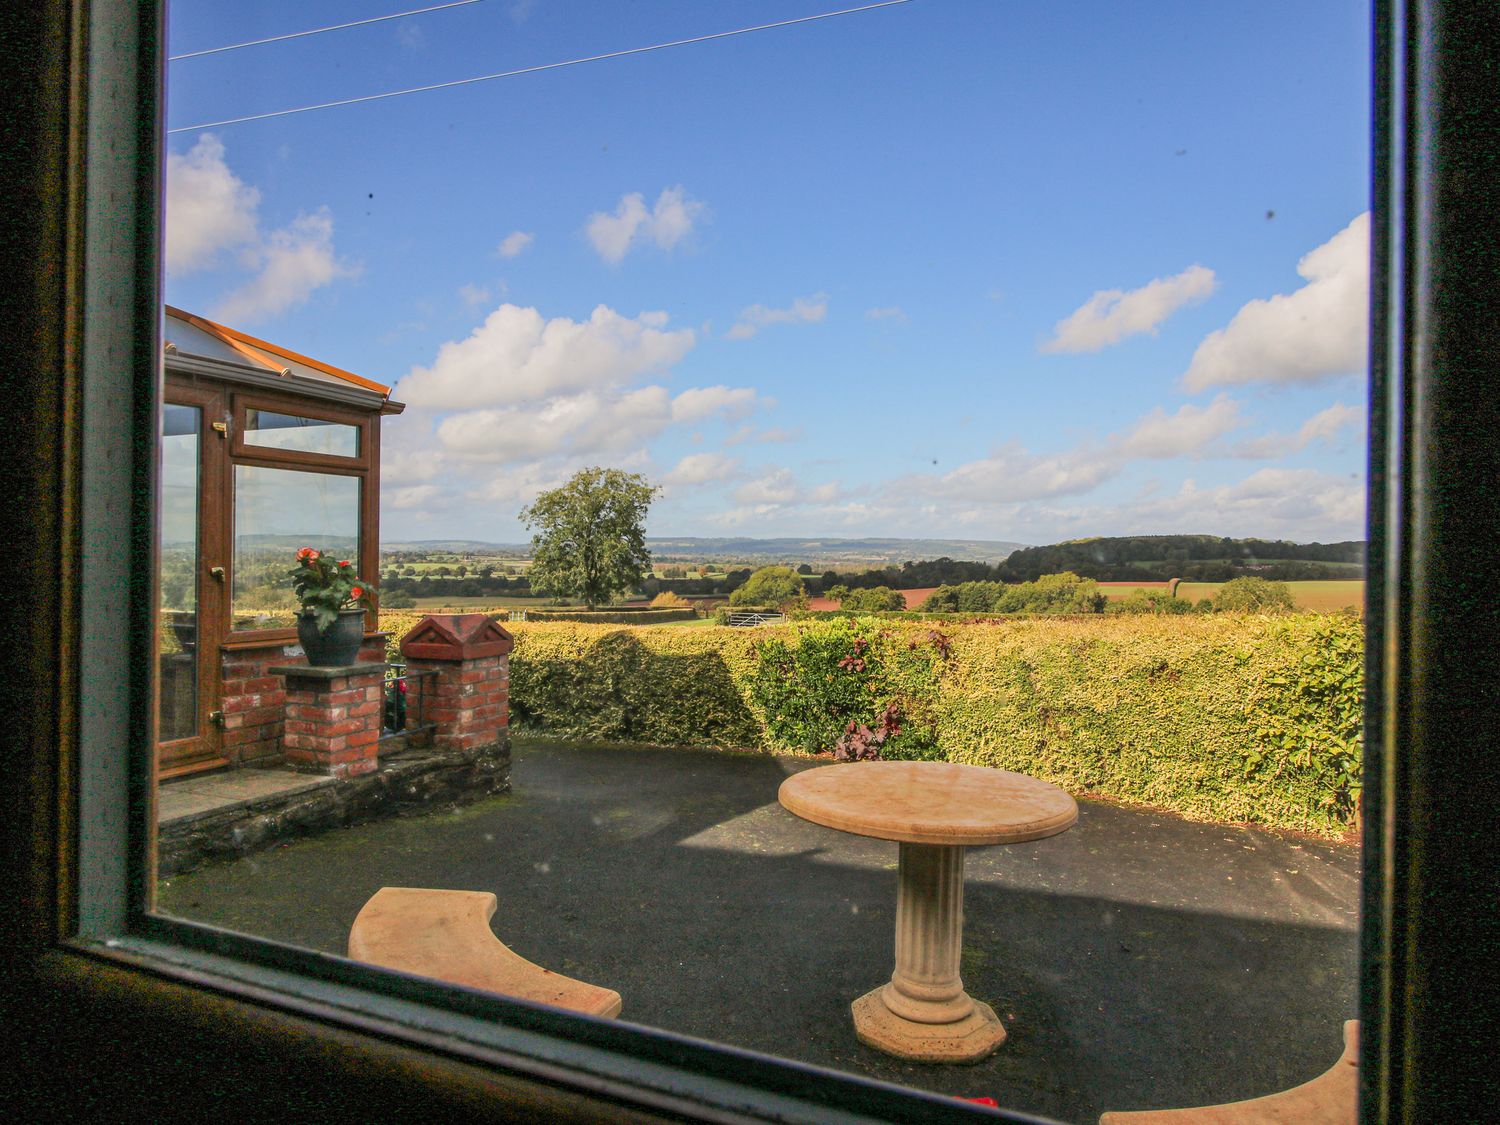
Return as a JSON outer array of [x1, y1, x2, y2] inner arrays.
[[396, 305, 695, 410]]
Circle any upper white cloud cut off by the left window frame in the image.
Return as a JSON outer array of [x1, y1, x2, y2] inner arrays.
[[167, 134, 261, 275]]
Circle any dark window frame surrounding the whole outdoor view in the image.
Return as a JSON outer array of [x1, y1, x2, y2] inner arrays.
[[0, 0, 1500, 1122]]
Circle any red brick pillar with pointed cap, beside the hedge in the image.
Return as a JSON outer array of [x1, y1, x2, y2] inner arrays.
[[401, 614, 516, 750]]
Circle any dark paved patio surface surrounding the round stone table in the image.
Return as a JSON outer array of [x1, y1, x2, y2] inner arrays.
[[161, 738, 1359, 1122]]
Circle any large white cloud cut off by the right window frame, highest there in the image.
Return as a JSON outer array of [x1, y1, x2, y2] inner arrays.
[[1182, 212, 1370, 390]]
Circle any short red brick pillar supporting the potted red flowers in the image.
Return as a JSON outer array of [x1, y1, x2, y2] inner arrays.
[[267, 663, 386, 777]]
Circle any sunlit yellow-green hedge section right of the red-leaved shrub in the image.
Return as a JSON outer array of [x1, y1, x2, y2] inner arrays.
[[936, 614, 1364, 836]]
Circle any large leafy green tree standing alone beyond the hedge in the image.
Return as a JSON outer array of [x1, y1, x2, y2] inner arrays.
[[521, 468, 657, 609]]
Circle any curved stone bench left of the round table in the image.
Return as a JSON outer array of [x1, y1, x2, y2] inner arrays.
[[350, 887, 621, 1017]]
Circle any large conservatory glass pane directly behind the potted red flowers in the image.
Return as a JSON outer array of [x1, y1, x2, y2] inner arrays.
[[233, 465, 360, 630]]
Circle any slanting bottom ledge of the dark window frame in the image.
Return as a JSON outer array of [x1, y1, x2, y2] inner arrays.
[[35, 936, 1041, 1125]]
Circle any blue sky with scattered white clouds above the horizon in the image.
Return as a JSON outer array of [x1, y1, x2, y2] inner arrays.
[[167, 0, 1370, 543]]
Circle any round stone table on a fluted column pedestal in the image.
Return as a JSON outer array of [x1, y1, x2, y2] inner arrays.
[[777, 762, 1079, 1062]]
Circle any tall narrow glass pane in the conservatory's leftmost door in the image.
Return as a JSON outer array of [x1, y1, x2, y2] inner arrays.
[[159, 405, 203, 743]]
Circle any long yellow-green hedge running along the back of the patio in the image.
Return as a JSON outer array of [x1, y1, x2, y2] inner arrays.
[[383, 614, 1364, 837]]
